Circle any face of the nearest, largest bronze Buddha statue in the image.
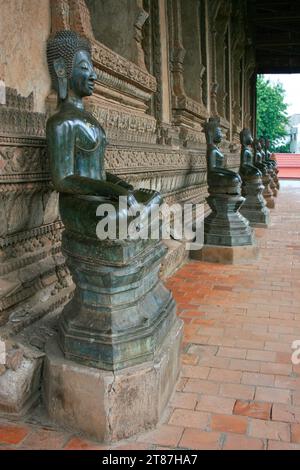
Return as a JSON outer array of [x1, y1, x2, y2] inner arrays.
[[70, 51, 97, 98]]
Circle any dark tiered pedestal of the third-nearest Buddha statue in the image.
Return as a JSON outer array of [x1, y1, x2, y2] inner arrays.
[[241, 178, 270, 228]]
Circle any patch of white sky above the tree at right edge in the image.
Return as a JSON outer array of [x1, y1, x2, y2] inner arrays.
[[265, 73, 300, 116]]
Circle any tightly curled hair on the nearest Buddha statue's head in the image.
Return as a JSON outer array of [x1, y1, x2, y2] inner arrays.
[[47, 30, 91, 89]]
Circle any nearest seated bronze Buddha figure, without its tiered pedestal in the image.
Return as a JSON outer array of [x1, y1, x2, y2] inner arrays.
[[46, 31, 161, 235]]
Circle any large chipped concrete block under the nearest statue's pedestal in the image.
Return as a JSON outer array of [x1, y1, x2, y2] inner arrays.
[[43, 319, 183, 442]]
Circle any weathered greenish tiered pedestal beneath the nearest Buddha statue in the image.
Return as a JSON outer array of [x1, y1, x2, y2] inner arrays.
[[55, 196, 176, 370]]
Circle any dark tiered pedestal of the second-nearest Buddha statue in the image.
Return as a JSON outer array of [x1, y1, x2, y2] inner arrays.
[[204, 194, 255, 246]]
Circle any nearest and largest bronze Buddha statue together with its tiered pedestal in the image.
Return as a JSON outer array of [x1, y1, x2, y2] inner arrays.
[[47, 31, 177, 370]]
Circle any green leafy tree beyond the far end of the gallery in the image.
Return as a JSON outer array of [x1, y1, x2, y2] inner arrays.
[[256, 75, 288, 150]]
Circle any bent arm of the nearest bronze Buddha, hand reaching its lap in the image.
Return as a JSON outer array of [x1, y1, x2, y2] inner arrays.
[[47, 121, 136, 201]]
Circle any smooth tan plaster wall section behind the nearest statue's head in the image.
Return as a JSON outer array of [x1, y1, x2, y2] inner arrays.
[[0, 0, 51, 112]]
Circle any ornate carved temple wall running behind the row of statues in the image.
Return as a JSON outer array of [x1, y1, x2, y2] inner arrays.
[[0, 0, 254, 368]]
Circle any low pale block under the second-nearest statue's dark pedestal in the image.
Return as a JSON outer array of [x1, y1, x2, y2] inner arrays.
[[191, 244, 259, 264]]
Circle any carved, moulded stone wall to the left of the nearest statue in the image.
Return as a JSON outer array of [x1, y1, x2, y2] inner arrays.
[[0, 88, 72, 346]]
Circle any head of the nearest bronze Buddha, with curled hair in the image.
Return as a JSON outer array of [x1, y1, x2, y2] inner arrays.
[[47, 30, 97, 100]]
